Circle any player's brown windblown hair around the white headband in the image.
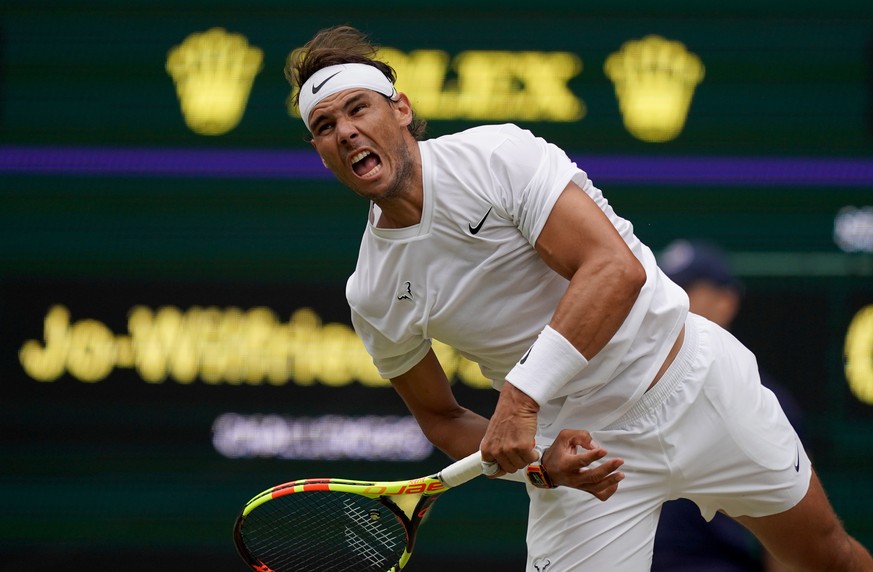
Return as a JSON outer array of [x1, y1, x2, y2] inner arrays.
[[285, 26, 427, 139]]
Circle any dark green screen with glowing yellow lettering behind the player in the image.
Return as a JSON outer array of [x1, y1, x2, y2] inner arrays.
[[0, 0, 873, 571]]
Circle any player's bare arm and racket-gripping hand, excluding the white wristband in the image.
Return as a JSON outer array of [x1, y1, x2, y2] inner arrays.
[[482, 182, 646, 478]]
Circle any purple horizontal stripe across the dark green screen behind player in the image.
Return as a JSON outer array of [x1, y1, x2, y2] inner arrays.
[[0, 147, 873, 186]]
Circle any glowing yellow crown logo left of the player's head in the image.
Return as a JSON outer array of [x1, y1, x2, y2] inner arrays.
[[167, 28, 264, 135]]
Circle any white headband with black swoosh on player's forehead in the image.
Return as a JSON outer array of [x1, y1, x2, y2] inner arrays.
[[298, 64, 397, 132]]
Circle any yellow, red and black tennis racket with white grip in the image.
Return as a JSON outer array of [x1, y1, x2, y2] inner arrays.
[[234, 451, 497, 572]]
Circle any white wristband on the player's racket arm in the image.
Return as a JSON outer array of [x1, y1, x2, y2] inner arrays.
[[506, 326, 588, 406]]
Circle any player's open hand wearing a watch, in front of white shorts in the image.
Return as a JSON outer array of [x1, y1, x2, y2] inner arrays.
[[541, 429, 624, 501]]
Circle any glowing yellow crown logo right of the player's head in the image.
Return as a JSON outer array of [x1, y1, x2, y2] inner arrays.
[[603, 35, 704, 143]]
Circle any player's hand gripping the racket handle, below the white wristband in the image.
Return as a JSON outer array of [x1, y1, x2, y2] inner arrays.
[[480, 382, 540, 475]]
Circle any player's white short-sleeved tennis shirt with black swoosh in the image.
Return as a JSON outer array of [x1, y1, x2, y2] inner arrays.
[[346, 124, 688, 428]]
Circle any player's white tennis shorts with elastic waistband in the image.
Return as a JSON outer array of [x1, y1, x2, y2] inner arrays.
[[527, 314, 812, 572]]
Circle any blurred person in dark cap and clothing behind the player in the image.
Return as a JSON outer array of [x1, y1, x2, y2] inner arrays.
[[652, 239, 803, 572]]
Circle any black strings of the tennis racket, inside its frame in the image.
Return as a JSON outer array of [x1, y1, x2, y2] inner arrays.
[[241, 491, 407, 572]]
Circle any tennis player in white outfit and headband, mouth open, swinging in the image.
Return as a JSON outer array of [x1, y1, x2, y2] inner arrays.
[[285, 26, 873, 572]]
